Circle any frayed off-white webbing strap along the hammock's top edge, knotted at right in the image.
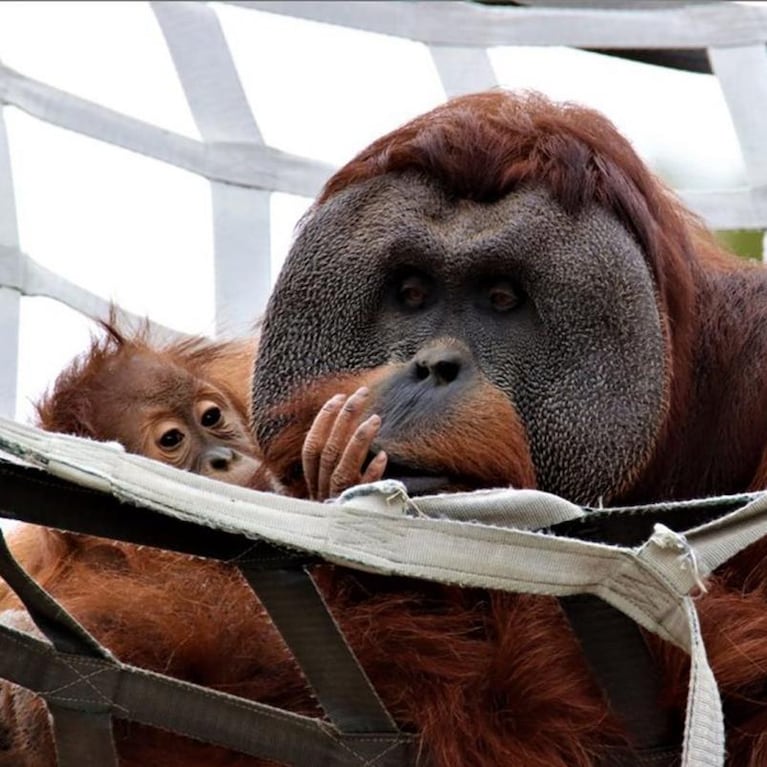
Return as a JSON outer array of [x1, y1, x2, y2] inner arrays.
[[0, 420, 767, 767]]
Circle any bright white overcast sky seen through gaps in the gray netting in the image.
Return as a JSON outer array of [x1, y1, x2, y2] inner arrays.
[[0, 1, 743, 420]]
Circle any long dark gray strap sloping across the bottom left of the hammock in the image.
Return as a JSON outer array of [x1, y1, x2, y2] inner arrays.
[[0, 625, 416, 767]]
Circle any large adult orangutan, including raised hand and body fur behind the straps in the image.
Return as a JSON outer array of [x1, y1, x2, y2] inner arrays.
[[254, 91, 767, 767]]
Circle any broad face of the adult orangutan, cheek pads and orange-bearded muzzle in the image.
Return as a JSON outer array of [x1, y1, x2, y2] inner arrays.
[[255, 175, 667, 502]]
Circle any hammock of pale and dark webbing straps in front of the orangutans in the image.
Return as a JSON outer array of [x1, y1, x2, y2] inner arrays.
[[0, 420, 767, 767]]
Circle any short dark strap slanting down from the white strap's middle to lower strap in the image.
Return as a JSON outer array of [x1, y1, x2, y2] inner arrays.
[[240, 567, 397, 733]]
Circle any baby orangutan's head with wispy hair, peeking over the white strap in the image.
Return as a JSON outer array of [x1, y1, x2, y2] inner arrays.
[[38, 324, 271, 489]]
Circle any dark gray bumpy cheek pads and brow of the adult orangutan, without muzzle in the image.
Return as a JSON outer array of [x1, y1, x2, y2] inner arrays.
[[254, 173, 668, 503]]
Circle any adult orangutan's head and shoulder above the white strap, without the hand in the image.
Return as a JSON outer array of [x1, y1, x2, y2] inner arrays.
[[255, 92, 767, 504]]
